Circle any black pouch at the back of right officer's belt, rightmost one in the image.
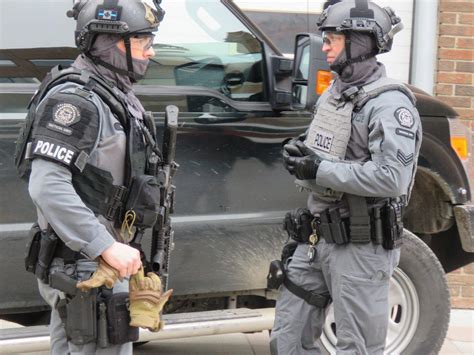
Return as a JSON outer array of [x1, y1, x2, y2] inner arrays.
[[380, 201, 403, 250]]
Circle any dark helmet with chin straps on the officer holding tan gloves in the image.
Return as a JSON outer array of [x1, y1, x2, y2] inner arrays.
[[67, 0, 165, 82]]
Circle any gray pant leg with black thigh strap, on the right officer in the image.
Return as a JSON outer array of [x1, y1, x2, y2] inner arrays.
[[270, 244, 327, 355]]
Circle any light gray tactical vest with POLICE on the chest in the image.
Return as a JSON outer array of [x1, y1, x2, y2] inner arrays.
[[296, 77, 416, 202]]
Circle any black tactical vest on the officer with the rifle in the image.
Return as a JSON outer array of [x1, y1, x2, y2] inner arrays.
[[14, 66, 156, 223]]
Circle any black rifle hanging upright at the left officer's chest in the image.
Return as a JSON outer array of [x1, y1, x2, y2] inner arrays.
[[150, 105, 179, 290]]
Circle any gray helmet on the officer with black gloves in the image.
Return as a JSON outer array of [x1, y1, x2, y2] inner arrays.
[[317, 0, 403, 54]]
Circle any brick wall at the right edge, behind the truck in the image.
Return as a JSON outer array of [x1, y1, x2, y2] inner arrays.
[[435, 0, 474, 309]]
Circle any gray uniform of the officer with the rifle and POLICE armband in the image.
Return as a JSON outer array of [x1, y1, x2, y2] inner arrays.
[[29, 64, 143, 355]]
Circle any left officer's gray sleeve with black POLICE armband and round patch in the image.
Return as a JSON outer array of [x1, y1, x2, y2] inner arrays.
[[29, 87, 115, 259]]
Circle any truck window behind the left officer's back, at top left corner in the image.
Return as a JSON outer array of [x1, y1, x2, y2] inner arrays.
[[0, 0, 78, 84]]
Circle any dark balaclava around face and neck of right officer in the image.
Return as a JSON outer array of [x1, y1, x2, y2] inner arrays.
[[330, 31, 386, 98]]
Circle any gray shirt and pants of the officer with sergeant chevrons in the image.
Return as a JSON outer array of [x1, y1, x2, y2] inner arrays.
[[271, 77, 421, 355]]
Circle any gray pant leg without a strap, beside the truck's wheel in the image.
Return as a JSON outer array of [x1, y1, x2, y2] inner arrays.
[[329, 243, 400, 355]]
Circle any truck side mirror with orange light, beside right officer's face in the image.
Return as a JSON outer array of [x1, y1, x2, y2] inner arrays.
[[292, 33, 332, 111]]
